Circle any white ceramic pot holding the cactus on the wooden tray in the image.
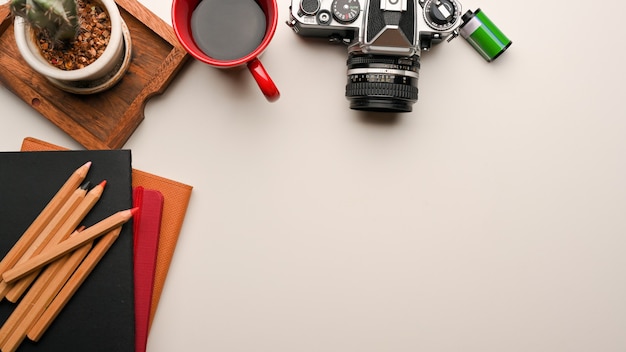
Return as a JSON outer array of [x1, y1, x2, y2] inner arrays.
[[14, 0, 131, 94]]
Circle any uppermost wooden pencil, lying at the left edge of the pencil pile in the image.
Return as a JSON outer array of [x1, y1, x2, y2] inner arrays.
[[0, 161, 91, 275]]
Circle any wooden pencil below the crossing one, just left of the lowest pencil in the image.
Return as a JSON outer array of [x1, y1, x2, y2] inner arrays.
[[0, 242, 93, 352]]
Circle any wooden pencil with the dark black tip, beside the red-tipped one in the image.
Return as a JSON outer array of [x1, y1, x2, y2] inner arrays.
[[0, 182, 89, 302]]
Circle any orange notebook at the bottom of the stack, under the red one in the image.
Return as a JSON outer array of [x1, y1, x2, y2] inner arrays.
[[21, 137, 193, 325]]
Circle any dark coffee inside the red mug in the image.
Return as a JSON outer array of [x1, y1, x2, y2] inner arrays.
[[191, 0, 266, 61]]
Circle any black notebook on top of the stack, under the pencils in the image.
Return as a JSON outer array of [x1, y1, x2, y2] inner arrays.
[[0, 150, 135, 352]]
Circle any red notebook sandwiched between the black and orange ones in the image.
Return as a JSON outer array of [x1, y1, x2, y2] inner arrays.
[[133, 186, 163, 352]]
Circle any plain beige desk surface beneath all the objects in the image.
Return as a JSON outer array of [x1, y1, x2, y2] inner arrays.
[[0, 0, 626, 352]]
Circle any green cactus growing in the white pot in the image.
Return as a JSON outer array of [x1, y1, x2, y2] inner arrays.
[[11, 0, 80, 43]]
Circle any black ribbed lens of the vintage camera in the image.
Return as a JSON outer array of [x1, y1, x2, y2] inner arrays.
[[346, 53, 420, 112]]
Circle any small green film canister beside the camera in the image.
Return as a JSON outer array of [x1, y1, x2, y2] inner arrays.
[[460, 9, 513, 62]]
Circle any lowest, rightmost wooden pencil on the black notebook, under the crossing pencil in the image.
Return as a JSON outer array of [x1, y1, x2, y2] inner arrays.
[[27, 226, 122, 341]]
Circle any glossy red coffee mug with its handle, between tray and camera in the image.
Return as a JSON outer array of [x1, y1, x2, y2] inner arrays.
[[172, 0, 280, 101]]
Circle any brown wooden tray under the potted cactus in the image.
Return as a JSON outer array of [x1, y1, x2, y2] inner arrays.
[[0, 0, 189, 149]]
